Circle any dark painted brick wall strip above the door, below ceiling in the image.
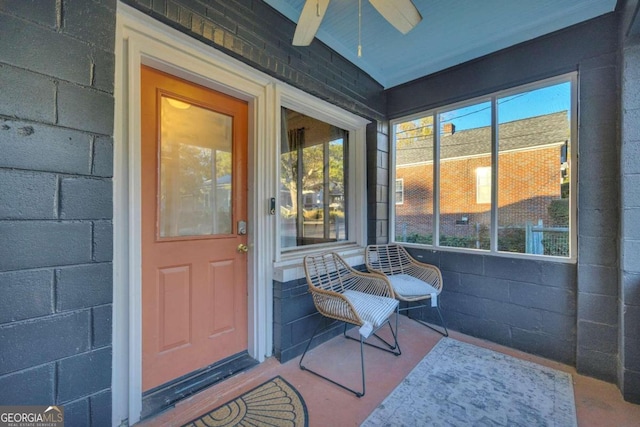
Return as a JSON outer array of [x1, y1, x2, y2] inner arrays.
[[124, 0, 385, 119]]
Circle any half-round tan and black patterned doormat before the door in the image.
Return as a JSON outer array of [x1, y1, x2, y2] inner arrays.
[[183, 376, 308, 427]]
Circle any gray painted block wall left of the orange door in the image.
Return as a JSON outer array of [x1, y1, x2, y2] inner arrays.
[[0, 0, 116, 426]]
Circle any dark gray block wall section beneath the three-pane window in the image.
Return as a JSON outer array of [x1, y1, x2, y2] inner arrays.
[[409, 248, 576, 365]]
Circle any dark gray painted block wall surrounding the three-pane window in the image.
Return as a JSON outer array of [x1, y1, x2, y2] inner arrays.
[[387, 13, 620, 382]]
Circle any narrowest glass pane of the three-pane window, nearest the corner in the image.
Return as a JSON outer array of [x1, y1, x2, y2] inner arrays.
[[394, 115, 433, 245]]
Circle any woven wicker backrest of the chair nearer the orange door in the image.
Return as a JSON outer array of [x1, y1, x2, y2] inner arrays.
[[304, 252, 357, 293]]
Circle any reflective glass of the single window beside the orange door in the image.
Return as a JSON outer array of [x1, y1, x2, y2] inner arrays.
[[280, 108, 348, 248]]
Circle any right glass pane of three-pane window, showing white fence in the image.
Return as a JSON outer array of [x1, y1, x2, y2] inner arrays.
[[498, 82, 571, 256]]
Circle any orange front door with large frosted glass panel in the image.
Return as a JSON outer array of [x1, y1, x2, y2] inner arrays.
[[141, 66, 248, 391]]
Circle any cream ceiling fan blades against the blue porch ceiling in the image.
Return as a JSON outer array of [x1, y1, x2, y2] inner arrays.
[[293, 0, 422, 46]]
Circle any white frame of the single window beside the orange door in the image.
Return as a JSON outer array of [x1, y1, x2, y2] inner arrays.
[[274, 86, 369, 265]]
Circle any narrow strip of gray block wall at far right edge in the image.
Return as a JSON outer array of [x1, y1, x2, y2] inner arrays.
[[619, 1, 640, 403]]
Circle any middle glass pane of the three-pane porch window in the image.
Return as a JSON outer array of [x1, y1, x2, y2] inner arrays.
[[439, 102, 491, 250]]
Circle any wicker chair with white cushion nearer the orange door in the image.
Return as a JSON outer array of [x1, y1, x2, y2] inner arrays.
[[299, 252, 401, 397]]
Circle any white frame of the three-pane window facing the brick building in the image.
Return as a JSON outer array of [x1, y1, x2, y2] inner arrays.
[[388, 71, 579, 263]]
